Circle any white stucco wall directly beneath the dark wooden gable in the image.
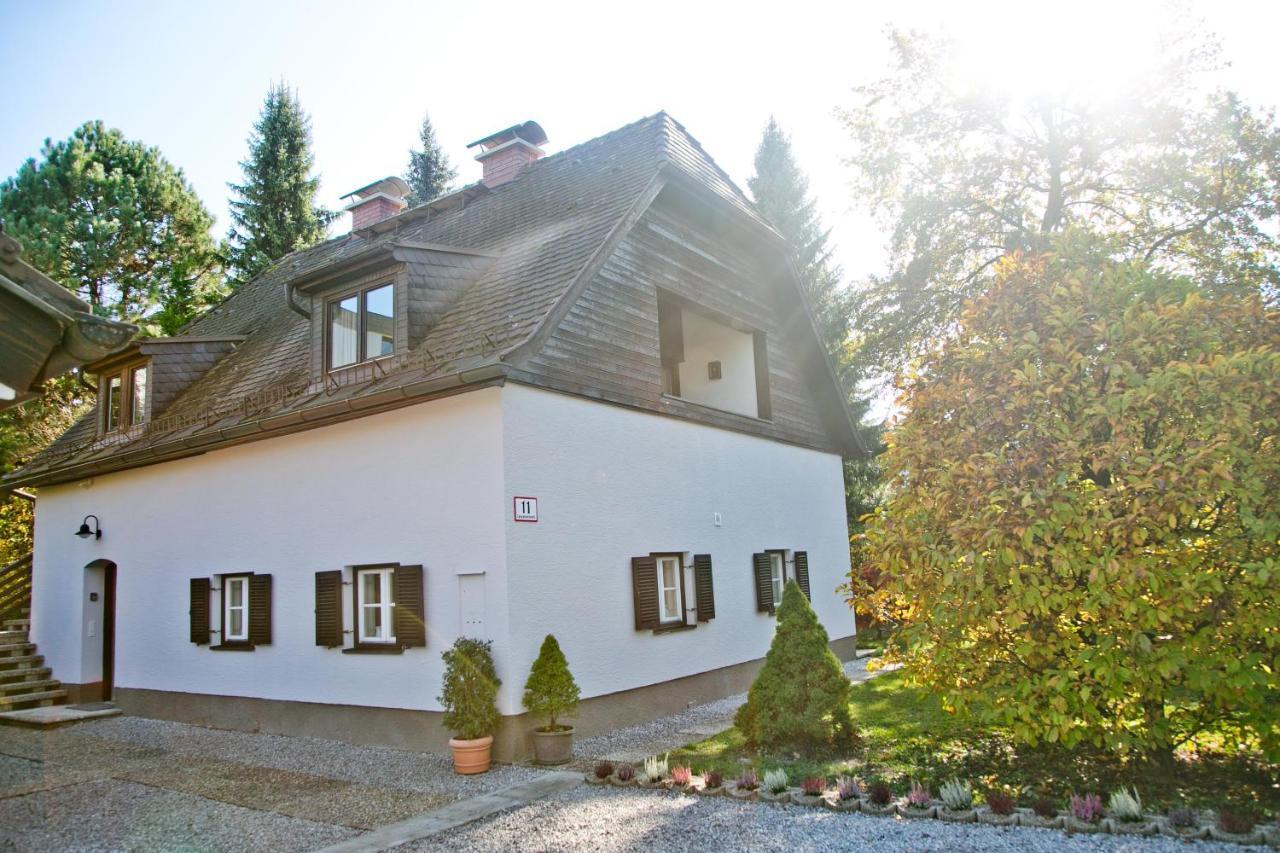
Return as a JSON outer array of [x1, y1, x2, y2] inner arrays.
[[502, 386, 854, 697]]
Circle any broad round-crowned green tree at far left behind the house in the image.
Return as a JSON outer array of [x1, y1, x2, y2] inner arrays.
[[0, 122, 220, 334]]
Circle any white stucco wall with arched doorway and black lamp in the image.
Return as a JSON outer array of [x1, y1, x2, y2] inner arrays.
[[32, 388, 518, 710]]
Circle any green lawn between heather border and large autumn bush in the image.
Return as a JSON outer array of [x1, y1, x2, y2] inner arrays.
[[671, 672, 1280, 816]]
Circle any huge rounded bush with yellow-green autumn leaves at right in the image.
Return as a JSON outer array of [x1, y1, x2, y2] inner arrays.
[[865, 246, 1280, 758]]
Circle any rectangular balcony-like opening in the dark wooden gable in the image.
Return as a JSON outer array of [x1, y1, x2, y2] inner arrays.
[[658, 291, 773, 420]]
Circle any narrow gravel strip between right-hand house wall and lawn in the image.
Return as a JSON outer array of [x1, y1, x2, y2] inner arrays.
[[573, 648, 897, 768]]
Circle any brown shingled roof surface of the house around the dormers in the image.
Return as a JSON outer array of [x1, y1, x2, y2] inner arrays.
[[4, 113, 849, 487]]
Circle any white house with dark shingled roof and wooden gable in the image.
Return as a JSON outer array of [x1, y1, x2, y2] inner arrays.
[[5, 114, 859, 757]]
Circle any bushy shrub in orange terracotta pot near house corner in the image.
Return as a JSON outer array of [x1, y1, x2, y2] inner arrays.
[[439, 637, 502, 775]]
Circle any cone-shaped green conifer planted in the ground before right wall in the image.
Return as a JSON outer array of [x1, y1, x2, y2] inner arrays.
[[733, 580, 856, 749]]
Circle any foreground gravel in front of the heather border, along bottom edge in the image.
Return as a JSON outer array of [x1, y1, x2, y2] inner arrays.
[[422, 785, 1244, 853]]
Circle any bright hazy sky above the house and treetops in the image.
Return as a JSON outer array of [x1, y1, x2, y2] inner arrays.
[[0, 0, 1280, 285]]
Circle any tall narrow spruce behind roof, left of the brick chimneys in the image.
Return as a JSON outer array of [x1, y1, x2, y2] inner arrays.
[[228, 83, 333, 284]]
